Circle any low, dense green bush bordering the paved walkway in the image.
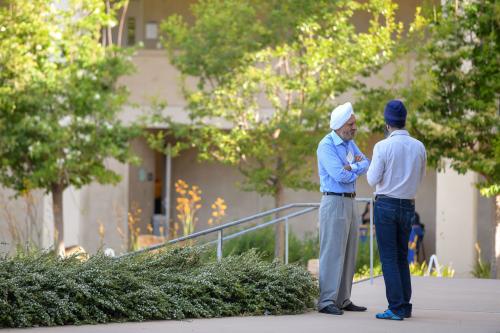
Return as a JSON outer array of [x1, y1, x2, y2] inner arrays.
[[0, 247, 317, 327]]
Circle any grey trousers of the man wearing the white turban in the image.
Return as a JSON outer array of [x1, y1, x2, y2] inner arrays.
[[318, 195, 359, 310]]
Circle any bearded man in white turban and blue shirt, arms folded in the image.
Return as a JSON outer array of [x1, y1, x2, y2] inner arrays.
[[317, 103, 369, 315]]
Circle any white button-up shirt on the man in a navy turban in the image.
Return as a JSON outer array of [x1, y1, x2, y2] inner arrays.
[[367, 130, 427, 199]]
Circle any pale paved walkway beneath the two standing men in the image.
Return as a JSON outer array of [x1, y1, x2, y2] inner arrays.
[[2, 277, 500, 333]]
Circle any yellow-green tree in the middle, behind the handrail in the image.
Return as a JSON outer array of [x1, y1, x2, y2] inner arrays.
[[150, 0, 401, 258]]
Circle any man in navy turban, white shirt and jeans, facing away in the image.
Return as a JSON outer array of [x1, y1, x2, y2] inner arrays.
[[367, 100, 426, 320]]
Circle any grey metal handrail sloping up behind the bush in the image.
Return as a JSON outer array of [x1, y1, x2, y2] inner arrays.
[[116, 198, 373, 284]]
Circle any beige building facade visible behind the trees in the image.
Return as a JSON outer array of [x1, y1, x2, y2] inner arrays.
[[0, 0, 495, 276]]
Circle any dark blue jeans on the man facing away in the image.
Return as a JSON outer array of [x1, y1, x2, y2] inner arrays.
[[374, 197, 415, 316]]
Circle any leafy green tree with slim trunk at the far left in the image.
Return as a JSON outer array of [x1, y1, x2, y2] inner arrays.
[[0, 0, 140, 254]]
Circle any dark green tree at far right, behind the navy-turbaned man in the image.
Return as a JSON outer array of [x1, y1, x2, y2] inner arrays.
[[359, 0, 500, 270]]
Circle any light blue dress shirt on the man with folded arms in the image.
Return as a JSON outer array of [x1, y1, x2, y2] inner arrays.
[[316, 131, 370, 193]]
